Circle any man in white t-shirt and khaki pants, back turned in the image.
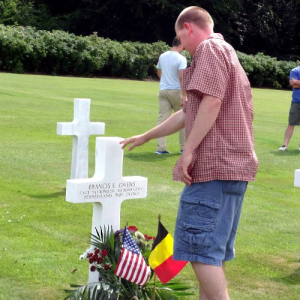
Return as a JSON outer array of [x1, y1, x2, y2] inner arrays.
[[155, 37, 187, 154]]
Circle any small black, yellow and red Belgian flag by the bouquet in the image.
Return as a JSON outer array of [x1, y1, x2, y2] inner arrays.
[[149, 221, 187, 284]]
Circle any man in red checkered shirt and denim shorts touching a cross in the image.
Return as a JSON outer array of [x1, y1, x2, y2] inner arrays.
[[122, 6, 258, 300]]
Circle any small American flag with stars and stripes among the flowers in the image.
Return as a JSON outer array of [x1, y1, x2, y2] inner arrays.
[[115, 227, 150, 285]]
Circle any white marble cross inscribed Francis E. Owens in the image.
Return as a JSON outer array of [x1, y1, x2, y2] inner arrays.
[[66, 137, 147, 282]]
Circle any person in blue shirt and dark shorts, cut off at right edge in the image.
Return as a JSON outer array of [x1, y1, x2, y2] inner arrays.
[[278, 66, 300, 151]]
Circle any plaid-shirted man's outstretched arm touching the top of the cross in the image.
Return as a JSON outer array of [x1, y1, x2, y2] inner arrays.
[[120, 109, 185, 151]]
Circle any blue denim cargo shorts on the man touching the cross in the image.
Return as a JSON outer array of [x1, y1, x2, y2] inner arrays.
[[173, 180, 247, 266]]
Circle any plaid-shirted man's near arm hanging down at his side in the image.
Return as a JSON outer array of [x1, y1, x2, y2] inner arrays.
[[178, 95, 222, 185]]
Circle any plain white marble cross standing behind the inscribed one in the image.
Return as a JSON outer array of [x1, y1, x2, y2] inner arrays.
[[57, 99, 105, 179]]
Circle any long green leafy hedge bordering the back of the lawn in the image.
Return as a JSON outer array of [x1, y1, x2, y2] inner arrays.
[[0, 25, 300, 88]]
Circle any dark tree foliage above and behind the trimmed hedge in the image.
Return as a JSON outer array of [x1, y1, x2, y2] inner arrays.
[[0, 0, 300, 60]]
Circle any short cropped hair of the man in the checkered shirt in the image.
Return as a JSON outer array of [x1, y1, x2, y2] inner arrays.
[[175, 6, 214, 29]]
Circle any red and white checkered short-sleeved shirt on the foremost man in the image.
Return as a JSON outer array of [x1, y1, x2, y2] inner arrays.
[[173, 33, 258, 183]]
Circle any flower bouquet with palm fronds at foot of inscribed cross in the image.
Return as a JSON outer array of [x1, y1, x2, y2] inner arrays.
[[65, 226, 191, 300]]
